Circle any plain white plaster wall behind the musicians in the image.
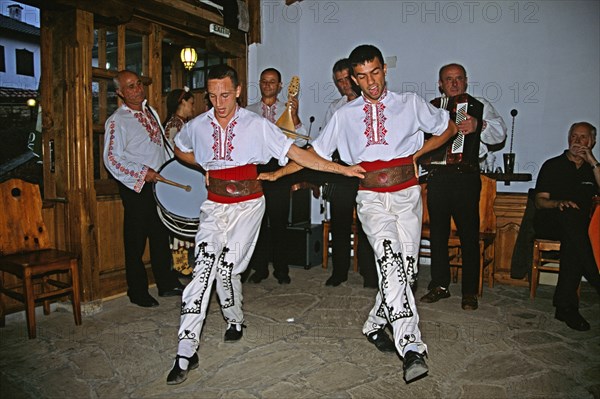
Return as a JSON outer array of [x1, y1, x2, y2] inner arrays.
[[248, 0, 600, 198]]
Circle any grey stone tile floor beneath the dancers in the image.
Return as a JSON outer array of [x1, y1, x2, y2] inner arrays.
[[0, 267, 600, 399]]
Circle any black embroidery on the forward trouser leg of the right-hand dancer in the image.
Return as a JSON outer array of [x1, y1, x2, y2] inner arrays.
[[377, 240, 413, 323]]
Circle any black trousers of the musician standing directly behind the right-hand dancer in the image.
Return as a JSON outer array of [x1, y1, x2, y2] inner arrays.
[[323, 174, 377, 285]]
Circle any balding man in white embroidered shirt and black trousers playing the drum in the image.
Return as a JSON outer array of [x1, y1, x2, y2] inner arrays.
[[104, 71, 182, 307]]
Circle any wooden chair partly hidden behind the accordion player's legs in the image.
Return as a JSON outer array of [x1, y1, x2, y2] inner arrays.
[[419, 175, 496, 296]]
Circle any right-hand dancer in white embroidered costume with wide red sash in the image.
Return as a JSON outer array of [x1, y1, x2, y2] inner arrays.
[[262, 45, 458, 383]]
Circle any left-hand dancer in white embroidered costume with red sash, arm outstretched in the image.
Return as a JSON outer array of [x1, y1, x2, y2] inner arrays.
[[167, 65, 362, 384]]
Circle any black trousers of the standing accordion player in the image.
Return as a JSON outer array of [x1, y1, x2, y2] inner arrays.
[[427, 172, 481, 296]]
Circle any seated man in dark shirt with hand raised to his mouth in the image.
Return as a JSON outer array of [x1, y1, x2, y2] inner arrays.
[[534, 122, 600, 331]]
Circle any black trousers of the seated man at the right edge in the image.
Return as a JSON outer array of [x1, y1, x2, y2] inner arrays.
[[535, 208, 600, 309]]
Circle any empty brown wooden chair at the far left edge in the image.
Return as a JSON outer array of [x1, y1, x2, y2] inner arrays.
[[0, 179, 81, 339]]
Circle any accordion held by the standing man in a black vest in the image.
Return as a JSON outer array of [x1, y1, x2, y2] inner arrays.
[[419, 93, 483, 169]]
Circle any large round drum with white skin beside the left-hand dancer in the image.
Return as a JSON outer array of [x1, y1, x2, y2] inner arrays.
[[154, 158, 208, 240]]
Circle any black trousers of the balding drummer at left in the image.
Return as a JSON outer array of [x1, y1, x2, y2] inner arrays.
[[119, 183, 180, 299]]
